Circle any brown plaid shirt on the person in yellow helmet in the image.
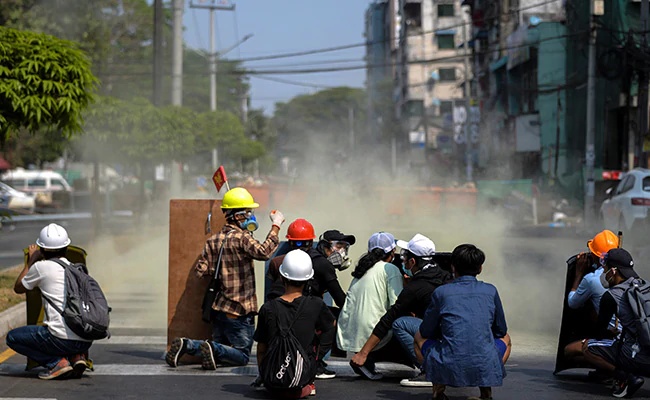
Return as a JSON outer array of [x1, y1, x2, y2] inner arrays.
[[196, 224, 280, 316]]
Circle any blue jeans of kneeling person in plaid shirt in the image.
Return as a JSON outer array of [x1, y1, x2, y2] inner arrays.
[[187, 311, 255, 365]]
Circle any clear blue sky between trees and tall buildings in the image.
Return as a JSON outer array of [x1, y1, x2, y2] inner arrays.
[[183, 0, 371, 114]]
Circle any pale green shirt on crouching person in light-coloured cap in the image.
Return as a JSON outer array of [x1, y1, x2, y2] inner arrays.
[[336, 261, 403, 352]]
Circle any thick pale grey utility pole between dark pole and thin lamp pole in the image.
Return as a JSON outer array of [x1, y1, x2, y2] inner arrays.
[[170, 0, 185, 196]]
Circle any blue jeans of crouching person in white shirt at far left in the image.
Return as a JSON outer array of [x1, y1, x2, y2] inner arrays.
[[7, 325, 92, 369]]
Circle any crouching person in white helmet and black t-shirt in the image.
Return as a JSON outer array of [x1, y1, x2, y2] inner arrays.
[[254, 250, 335, 399]]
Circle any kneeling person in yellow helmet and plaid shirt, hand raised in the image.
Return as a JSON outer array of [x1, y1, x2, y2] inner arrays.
[[165, 187, 284, 369]]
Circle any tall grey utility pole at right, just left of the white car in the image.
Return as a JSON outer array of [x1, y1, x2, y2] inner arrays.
[[584, 0, 596, 229]]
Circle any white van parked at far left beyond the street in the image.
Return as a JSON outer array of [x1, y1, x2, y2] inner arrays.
[[1, 168, 72, 206]]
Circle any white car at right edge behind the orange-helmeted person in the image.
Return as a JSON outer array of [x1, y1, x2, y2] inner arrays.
[[600, 168, 650, 232]]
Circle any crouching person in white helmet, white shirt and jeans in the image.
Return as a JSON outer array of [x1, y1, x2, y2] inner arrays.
[[7, 224, 92, 379]]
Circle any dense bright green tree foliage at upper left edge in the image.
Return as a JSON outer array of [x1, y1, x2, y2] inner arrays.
[[0, 27, 96, 141]]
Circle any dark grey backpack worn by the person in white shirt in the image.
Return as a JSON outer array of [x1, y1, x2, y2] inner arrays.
[[43, 258, 111, 340]]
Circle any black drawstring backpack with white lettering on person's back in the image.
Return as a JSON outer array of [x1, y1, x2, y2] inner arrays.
[[260, 297, 316, 390]]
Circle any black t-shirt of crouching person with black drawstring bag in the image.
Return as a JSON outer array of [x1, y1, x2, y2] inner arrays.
[[254, 296, 334, 353]]
